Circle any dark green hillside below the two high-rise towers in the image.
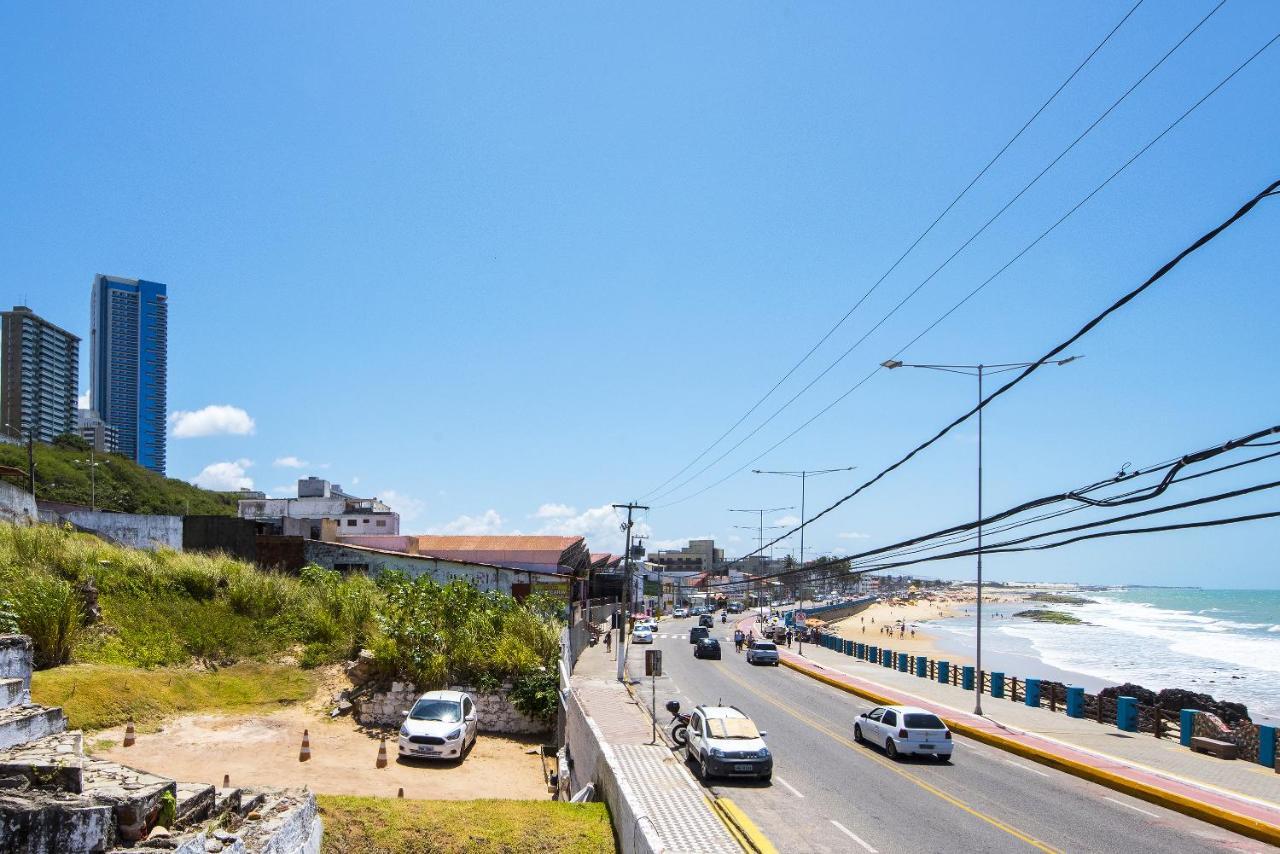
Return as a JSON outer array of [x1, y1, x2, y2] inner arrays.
[[0, 438, 236, 516]]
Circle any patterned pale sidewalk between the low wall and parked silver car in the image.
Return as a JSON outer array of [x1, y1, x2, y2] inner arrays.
[[570, 644, 742, 854]]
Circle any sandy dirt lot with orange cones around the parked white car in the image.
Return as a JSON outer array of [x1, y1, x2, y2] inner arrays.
[[86, 704, 549, 800]]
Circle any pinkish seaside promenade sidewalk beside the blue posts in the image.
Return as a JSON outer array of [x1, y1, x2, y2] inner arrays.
[[782, 627, 1280, 834]]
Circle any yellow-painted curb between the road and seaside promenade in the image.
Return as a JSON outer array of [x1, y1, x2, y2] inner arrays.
[[782, 661, 1280, 846]]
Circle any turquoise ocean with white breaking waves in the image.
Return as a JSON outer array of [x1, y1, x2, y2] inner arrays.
[[929, 588, 1280, 722]]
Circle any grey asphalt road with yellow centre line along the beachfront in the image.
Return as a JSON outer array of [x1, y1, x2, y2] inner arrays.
[[628, 617, 1272, 854]]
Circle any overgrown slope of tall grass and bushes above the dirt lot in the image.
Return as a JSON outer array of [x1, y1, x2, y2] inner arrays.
[[0, 524, 562, 716]]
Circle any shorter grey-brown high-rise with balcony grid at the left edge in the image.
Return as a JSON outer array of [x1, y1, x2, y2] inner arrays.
[[0, 306, 79, 442]]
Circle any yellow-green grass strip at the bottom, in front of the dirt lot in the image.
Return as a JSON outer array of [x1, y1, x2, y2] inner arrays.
[[316, 795, 616, 854]]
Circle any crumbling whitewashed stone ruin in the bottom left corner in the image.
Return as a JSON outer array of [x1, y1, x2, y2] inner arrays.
[[0, 635, 321, 854]]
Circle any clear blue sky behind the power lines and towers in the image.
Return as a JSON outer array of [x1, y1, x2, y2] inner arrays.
[[0, 0, 1280, 586]]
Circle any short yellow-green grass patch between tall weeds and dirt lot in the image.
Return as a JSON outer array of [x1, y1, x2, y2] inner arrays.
[[31, 662, 315, 730]]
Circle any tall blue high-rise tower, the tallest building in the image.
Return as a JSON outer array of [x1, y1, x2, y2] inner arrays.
[[90, 274, 169, 474]]
